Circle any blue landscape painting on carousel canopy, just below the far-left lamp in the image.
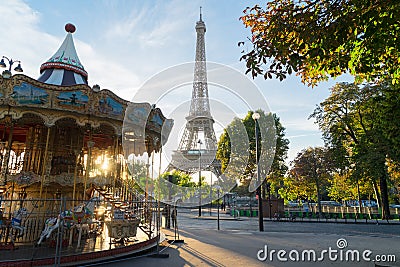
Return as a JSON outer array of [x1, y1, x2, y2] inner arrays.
[[11, 82, 49, 107]]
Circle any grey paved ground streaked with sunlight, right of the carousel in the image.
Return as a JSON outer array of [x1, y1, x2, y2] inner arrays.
[[89, 210, 400, 267]]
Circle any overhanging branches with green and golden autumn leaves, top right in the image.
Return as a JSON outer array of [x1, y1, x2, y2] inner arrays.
[[239, 0, 400, 86]]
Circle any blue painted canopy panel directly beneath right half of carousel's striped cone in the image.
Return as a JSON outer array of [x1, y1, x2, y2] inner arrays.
[[54, 90, 89, 111]]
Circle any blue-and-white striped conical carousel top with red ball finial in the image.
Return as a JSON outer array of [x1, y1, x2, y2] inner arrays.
[[38, 23, 88, 86]]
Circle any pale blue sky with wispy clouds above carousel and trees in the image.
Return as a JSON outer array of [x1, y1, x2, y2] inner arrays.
[[0, 0, 350, 165]]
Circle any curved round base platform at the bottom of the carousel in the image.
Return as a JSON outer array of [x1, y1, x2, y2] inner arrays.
[[0, 228, 165, 267]]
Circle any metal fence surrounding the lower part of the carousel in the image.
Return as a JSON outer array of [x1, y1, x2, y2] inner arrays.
[[0, 197, 159, 264]]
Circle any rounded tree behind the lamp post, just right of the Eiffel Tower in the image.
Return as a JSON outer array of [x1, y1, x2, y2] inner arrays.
[[216, 111, 289, 196]]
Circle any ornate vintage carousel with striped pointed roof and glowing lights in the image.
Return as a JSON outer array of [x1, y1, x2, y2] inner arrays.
[[0, 24, 172, 266]]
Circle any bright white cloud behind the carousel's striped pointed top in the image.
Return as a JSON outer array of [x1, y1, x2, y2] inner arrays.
[[0, 0, 140, 100]]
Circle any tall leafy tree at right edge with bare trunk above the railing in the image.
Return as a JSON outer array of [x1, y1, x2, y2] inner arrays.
[[310, 83, 399, 218]]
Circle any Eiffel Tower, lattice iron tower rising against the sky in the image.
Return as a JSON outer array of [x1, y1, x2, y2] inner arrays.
[[168, 8, 221, 176]]
